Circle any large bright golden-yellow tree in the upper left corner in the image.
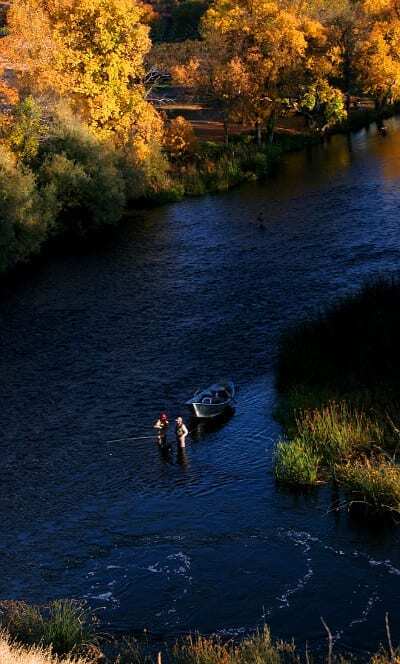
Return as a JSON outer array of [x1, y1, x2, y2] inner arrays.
[[0, 0, 161, 148]]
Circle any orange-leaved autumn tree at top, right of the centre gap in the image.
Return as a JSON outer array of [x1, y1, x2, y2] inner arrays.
[[175, 0, 307, 143]]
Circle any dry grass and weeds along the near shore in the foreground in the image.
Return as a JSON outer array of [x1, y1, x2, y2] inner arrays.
[[0, 600, 400, 664]]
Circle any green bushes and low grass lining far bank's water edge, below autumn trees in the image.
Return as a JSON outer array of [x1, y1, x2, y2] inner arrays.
[[0, 100, 398, 274]]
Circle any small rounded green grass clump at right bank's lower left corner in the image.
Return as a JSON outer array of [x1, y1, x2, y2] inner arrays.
[[274, 438, 320, 486]]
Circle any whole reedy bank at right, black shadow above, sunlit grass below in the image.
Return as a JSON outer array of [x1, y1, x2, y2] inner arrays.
[[275, 280, 400, 514]]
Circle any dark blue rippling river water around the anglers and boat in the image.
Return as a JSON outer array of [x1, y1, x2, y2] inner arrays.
[[0, 120, 400, 650]]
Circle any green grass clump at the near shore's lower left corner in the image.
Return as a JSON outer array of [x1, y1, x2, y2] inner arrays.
[[0, 600, 96, 655]]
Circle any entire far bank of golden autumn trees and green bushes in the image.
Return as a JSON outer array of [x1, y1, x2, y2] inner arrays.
[[0, 0, 400, 274]]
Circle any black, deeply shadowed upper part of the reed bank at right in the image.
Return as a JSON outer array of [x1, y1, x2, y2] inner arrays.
[[277, 279, 400, 395]]
